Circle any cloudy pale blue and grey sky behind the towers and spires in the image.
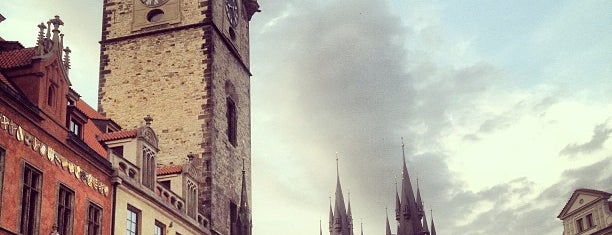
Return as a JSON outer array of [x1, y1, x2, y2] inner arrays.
[[0, 0, 612, 235]]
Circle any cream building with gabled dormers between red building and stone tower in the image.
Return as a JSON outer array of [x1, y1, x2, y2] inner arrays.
[[99, 121, 211, 235]]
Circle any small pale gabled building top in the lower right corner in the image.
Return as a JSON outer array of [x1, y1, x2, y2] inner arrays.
[[557, 189, 612, 235]]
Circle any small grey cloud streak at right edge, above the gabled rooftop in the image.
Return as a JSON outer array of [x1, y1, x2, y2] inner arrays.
[[559, 122, 612, 157]]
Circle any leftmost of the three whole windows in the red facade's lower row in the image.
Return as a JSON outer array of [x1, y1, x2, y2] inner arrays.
[[19, 164, 42, 234]]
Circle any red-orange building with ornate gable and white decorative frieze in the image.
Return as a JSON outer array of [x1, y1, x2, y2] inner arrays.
[[0, 16, 115, 235]]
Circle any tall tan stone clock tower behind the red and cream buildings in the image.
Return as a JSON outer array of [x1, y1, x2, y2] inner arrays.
[[98, 0, 259, 235]]
